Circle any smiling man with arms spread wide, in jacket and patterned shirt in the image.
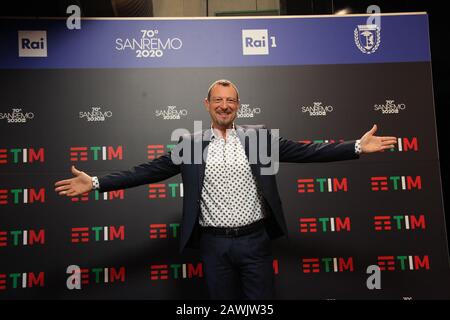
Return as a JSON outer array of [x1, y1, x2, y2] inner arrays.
[[55, 80, 397, 299]]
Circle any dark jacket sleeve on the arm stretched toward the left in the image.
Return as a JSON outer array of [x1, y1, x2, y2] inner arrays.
[[98, 153, 180, 192]]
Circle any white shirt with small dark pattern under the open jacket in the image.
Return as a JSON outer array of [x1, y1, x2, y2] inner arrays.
[[199, 126, 264, 227]]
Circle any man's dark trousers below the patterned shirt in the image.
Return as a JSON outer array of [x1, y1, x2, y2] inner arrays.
[[200, 227, 274, 300]]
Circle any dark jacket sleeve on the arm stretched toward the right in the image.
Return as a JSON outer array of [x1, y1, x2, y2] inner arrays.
[[279, 138, 359, 163]]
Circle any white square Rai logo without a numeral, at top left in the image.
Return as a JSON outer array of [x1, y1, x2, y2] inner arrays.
[[18, 30, 47, 57]]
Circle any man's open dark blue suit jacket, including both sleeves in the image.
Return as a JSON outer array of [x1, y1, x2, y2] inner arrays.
[[99, 125, 359, 251]]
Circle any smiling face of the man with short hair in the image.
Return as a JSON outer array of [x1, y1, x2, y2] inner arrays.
[[204, 85, 239, 128]]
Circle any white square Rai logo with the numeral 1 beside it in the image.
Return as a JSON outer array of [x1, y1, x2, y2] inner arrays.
[[242, 29, 277, 56]]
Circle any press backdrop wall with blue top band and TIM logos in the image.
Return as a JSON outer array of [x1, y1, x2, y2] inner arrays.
[[0, 13, 450, 299]]
